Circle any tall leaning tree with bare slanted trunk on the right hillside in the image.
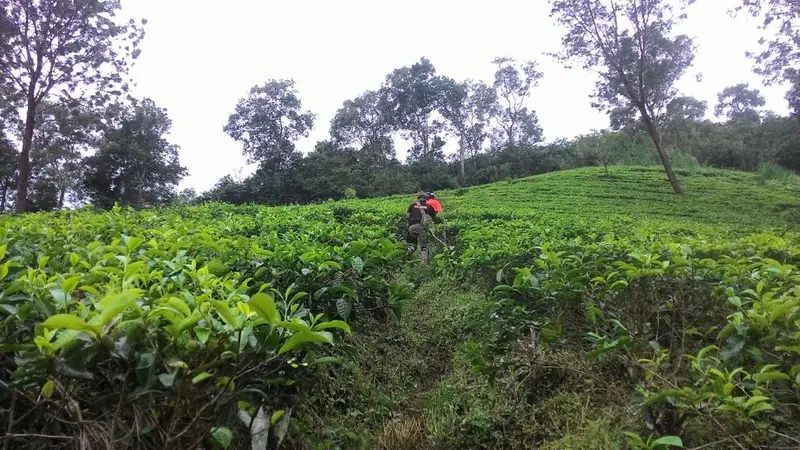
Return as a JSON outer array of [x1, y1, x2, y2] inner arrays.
[[550, 0, 694, 193]]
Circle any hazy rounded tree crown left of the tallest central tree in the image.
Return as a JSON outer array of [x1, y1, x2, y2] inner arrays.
[[330, 91, 395, 166]]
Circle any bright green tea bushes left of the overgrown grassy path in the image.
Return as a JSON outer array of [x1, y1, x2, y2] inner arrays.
[[0, 204, 407, 448]]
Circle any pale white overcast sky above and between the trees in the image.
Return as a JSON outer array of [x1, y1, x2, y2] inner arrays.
[[117, 0, 787, 193]]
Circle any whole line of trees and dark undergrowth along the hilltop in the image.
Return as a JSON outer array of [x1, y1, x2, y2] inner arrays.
[[0, 0, 800, 212]]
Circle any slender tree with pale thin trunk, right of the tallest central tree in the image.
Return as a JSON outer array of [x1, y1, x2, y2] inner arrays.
[[438, 77, 497, 182]]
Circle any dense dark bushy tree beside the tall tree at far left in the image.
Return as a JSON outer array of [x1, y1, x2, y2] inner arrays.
[[84, 99, 186, 208]]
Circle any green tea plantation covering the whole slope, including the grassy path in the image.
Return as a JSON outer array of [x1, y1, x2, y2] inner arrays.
[[0, 167, 800, 449]]
